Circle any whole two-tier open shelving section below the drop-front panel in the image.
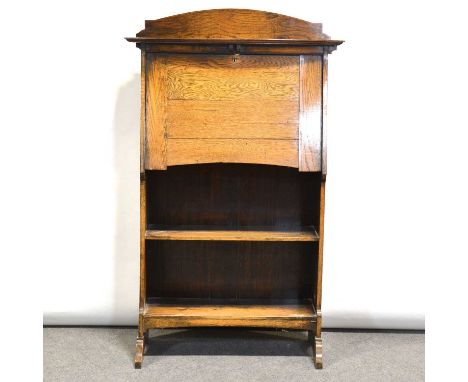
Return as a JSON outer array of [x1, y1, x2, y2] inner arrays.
[[144, 163, 321, 322]]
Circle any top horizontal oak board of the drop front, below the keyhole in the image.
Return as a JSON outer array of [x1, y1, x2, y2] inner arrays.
[[167, 55, 299, 100]]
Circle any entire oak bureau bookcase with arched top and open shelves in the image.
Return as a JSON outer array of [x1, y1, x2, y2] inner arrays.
[[127, 9, 342, 368]]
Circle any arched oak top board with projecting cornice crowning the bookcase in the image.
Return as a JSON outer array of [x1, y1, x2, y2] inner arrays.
[[127, 9, 341, 46]]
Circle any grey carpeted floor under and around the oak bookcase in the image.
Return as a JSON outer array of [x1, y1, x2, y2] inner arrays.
[[44, 328, 424, 382]]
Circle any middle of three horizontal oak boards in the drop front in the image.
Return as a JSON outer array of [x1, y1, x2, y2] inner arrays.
[[166, 99, 299, 139]]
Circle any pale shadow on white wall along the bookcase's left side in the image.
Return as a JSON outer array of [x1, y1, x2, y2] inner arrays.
[[112, 74, 140, 325]]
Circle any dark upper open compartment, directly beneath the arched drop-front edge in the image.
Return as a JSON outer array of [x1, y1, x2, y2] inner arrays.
[[146, 163, 321, 228]]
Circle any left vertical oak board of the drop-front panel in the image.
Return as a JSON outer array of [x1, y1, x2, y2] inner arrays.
[[145, 54, 167, 169]]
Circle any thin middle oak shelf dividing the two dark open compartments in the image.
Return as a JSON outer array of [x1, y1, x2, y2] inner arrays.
[[145, 226, 319, 241]]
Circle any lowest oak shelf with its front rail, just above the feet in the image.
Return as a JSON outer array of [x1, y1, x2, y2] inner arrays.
[[143, 299, 317, 330]]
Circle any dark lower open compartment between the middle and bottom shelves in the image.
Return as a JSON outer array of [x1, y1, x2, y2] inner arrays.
[[146, 240, 318, 305]]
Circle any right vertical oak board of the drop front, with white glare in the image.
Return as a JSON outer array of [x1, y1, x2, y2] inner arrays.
[[299, 56, 322, 171]]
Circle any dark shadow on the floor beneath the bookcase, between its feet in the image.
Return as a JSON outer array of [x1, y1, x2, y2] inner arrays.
[[145, 328, 311, 357]]
